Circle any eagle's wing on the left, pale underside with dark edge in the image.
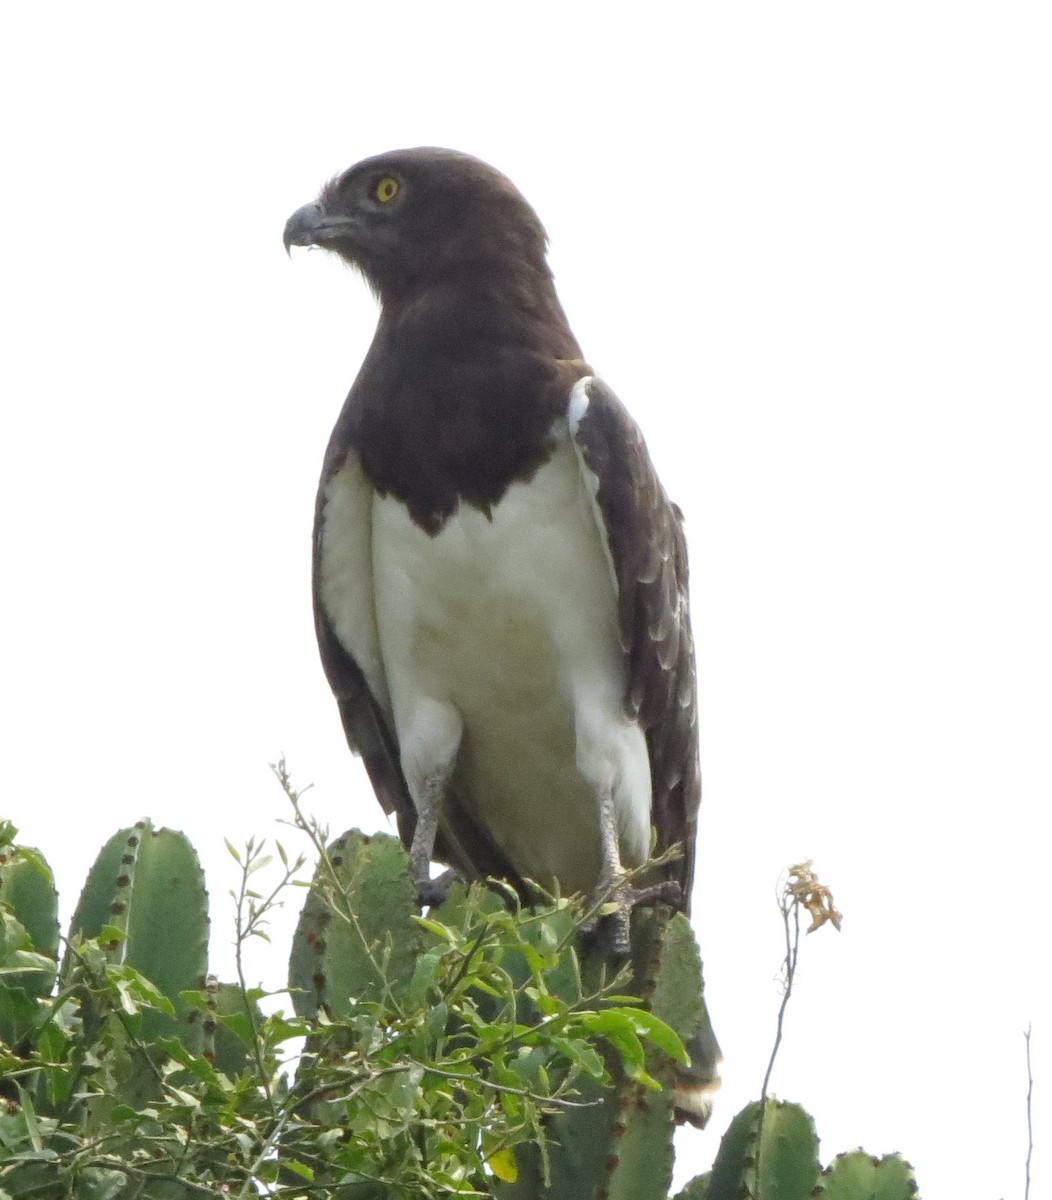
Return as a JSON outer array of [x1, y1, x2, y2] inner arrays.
[[313, 436, 515, 878]]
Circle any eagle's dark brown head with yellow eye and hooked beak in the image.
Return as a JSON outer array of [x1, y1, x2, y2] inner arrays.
[[284, 146, 551, 300]]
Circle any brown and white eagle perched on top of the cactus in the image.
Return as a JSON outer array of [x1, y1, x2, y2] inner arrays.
[[284, 148, 719, 1123]]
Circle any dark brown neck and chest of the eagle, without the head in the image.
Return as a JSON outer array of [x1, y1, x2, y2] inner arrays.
[[337, 280, 588, 534]]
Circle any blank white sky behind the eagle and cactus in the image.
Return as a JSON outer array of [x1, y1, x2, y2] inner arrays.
[[0, 0, 1052, 1200]]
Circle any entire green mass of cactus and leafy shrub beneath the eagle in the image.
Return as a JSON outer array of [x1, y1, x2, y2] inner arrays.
[[0, 811, 915, 1200]]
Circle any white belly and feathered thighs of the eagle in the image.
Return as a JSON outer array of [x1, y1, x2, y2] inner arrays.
[[372, 433, 650, 894]]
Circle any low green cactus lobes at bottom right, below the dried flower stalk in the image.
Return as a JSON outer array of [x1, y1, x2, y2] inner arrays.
[[677, 1099, 916, 1200]]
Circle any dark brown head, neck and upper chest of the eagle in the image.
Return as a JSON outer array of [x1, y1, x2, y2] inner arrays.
[[287, 150, 588, 532]]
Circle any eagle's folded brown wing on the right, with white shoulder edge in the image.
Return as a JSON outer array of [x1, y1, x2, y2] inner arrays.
[[567, 377, 701, 906]]
